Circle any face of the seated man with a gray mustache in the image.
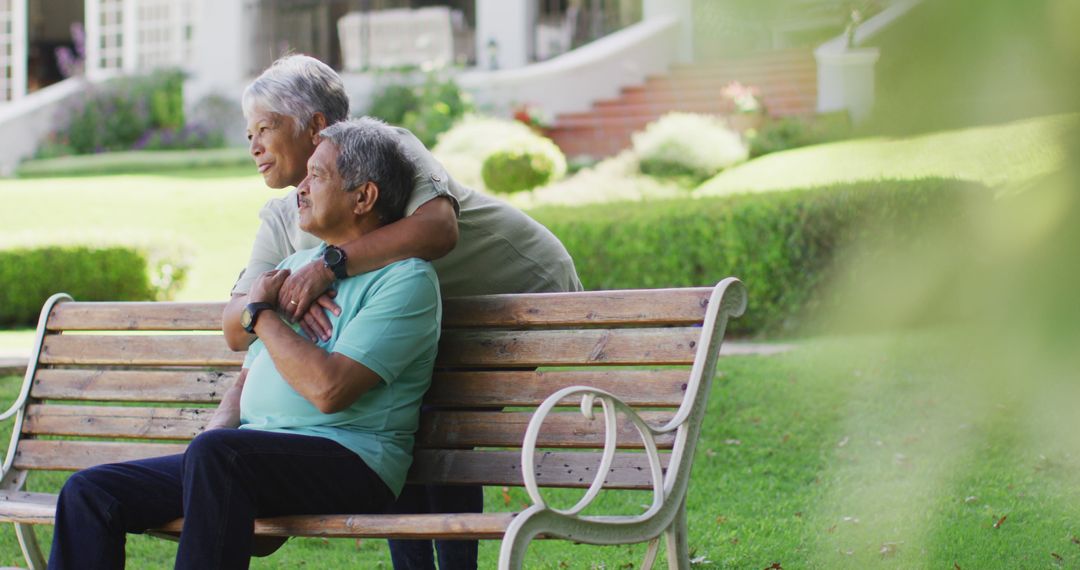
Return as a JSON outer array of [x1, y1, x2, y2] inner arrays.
[[296, 140, 355, 240]]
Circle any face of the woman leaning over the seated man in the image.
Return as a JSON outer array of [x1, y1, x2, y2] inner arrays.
[[247, 109, 315, 188]]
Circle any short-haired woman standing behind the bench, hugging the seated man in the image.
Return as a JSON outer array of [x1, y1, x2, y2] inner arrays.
[[212, 55, 581, 570]]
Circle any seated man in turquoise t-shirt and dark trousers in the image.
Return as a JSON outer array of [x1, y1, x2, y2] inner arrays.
[[49, 119, 442, 570]]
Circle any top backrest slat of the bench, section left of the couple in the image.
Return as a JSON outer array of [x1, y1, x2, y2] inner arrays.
[[48, 301, 225, 330]]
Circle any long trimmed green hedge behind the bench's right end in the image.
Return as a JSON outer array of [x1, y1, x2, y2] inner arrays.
[[530, 178, 991, 335]]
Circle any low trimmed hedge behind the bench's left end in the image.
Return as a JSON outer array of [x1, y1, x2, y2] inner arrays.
[[0, 245, 187, 326]]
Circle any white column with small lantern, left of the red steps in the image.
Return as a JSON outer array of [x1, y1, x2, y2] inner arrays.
[[476, 0, 537, 69]]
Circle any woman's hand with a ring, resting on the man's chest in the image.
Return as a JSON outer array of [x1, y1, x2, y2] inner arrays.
[[278, 259, 341, 341]]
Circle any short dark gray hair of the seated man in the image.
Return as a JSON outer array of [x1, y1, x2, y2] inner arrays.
[[319, 117, 416, 225]]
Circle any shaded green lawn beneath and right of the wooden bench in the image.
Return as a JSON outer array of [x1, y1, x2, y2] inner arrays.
[[0, 333, 1080, 570]]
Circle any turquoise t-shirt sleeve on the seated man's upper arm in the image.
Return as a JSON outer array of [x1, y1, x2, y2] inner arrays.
[[334, 264, 442, 384]]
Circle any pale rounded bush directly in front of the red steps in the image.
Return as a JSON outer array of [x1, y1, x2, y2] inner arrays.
[[633, 112, 750, 180]]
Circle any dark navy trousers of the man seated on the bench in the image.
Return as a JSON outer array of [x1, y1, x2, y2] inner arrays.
[[49, 430, 393, 569]]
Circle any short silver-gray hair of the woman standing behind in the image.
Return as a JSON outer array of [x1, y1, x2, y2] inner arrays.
[[243, 55, 349, 133]]
